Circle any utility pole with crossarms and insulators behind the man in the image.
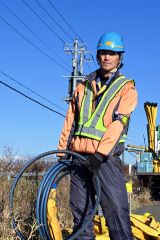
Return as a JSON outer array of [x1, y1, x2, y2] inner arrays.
[[64, 39, 92, 102]]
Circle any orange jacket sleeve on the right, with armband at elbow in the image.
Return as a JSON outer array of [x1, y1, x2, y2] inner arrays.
[[97, 82, 137, 156]]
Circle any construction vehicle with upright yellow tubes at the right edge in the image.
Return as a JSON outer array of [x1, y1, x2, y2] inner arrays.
[[126, 102, 160, 200]]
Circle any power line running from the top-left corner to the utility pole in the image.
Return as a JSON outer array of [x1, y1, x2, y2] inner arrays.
[[0, 0, 69, 66]]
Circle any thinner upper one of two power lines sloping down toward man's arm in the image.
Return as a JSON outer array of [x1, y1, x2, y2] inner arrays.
[[0, 70, 66, 112]]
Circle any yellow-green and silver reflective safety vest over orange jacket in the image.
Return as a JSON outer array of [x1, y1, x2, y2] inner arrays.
[[74, 76, 133, 142]]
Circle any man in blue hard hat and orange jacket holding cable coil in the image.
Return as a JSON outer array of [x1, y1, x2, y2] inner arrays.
[[58, 32, 137, 240]]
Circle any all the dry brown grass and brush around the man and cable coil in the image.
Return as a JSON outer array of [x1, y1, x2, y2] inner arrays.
[[0, 148, 156, 240]]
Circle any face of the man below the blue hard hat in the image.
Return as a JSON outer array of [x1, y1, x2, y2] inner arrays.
[[98, 50, 120, 72]]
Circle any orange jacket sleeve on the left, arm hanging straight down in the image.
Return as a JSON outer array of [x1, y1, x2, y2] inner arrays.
[[58, 94, 75, 150]]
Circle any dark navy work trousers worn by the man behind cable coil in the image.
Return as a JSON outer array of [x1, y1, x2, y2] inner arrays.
[[70, 156, 133, 240]]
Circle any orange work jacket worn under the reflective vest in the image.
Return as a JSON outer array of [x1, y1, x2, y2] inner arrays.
[[58, 71, 137, 156]]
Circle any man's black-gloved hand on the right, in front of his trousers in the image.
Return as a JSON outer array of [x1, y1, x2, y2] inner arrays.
[[84, 153, 103, 175]]
